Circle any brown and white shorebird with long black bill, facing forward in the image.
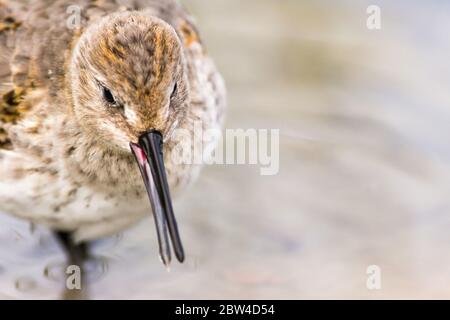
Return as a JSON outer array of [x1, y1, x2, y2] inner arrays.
[[0, 0, 226, 280]]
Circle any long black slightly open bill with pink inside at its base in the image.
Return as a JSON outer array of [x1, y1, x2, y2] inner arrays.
[[130, 131, 184, 266]]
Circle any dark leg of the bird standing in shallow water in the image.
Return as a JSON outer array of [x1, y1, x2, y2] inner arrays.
[[55, 231, 89, 300]]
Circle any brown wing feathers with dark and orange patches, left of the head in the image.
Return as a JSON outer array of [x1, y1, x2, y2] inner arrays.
[[0, 0, 79, 149]]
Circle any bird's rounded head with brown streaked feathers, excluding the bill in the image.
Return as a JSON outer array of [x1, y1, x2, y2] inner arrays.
[[70, 12, 189, 148]]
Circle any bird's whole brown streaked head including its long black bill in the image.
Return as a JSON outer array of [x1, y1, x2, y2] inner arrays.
[[70, 12, 189, 263]]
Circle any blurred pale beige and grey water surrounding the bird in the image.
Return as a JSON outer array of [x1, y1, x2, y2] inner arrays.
[[0, 0, 450, 299]]
